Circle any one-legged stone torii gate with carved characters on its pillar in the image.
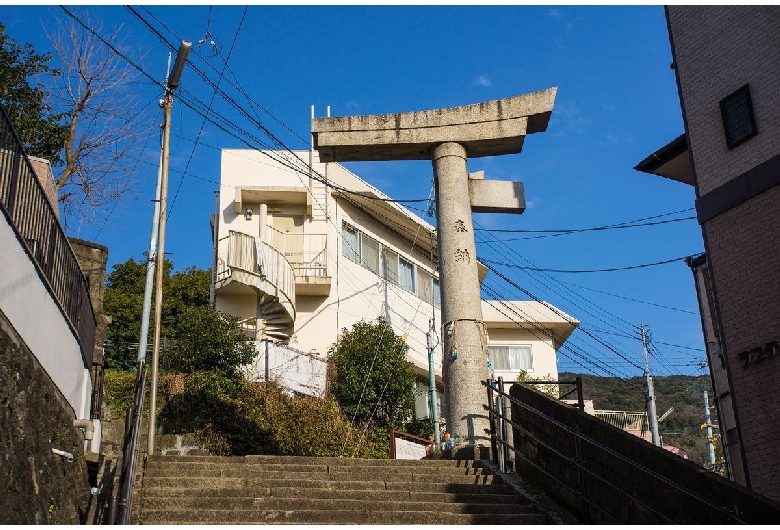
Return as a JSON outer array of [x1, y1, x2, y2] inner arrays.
[[311, 87, 557, 446]]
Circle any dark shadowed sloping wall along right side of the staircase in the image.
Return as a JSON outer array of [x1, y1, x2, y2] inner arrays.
[[509, 384, 780, 524]]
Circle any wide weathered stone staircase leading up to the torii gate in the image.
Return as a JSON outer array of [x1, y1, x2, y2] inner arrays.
[[137, 455, 551, 524]]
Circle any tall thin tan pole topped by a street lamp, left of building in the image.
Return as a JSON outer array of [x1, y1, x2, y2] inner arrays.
[[146, 40, 192, 455]]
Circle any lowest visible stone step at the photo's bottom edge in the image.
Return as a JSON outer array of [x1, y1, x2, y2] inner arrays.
[[142, 509, 547, 525]]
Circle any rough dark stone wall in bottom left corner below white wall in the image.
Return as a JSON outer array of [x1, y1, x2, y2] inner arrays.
[[0, 311, 93, 524]]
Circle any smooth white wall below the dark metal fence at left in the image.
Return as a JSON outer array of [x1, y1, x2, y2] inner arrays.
[[0, 209, 92, 419]]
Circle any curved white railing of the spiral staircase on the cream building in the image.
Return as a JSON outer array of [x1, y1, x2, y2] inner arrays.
[[217, 230, 295, 304]]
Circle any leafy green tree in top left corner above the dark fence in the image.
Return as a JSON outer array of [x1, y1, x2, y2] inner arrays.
[[0, 24, 69, 166]]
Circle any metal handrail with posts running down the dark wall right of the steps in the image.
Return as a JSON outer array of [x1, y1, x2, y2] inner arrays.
[[482, 377, 747, 524]]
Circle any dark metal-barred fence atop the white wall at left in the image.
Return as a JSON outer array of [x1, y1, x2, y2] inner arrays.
[[0, 103, 96, 368]]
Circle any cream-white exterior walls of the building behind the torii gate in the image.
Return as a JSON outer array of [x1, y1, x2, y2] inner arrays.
[[216, 150, 574, 381]]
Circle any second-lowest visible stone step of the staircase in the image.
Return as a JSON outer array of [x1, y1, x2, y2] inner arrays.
[[143, 494, 536, 514]]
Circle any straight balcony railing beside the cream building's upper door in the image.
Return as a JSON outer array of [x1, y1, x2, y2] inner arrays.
[[265, 226, 328, 276]]
